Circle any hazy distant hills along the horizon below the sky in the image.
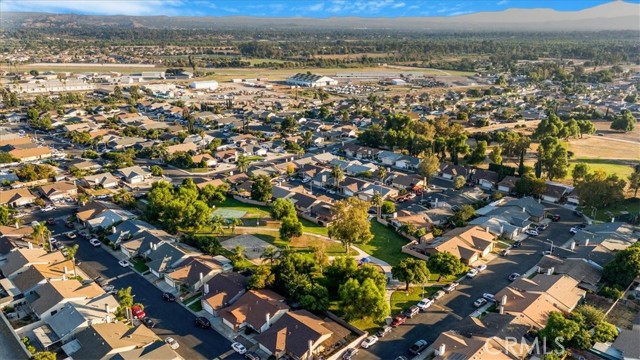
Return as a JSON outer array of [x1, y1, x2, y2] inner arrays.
[[0, 1, 640, 31]]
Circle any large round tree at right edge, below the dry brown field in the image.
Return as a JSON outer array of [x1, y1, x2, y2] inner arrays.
[[576, 170, 626, 208]]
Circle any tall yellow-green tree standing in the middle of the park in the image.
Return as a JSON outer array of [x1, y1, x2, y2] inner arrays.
[[329, 197, 373, 253]]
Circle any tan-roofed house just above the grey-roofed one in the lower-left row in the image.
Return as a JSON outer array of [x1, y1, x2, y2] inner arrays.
[[27, 279, 104, 321]]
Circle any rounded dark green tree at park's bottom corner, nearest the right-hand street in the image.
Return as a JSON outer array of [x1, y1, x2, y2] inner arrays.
[[338, 279, 389, 321]]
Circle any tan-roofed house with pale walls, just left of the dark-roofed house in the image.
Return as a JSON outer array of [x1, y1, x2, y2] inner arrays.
[[164, 255, 233, 291]]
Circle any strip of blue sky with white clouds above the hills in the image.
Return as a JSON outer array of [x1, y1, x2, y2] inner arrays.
[[0, 0, 640, 18]]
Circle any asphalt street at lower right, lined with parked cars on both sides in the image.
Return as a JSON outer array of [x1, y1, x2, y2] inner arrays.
[[355, 207, 582, 359]]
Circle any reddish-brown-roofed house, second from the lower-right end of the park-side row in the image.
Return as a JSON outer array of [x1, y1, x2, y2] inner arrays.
[[219, 290, 289, 333]]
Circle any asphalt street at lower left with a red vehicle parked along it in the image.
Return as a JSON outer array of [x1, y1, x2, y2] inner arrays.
[[25, 207, 243, 360]]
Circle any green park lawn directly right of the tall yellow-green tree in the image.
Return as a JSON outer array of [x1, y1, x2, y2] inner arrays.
[[355, 219, 409, 266]]
